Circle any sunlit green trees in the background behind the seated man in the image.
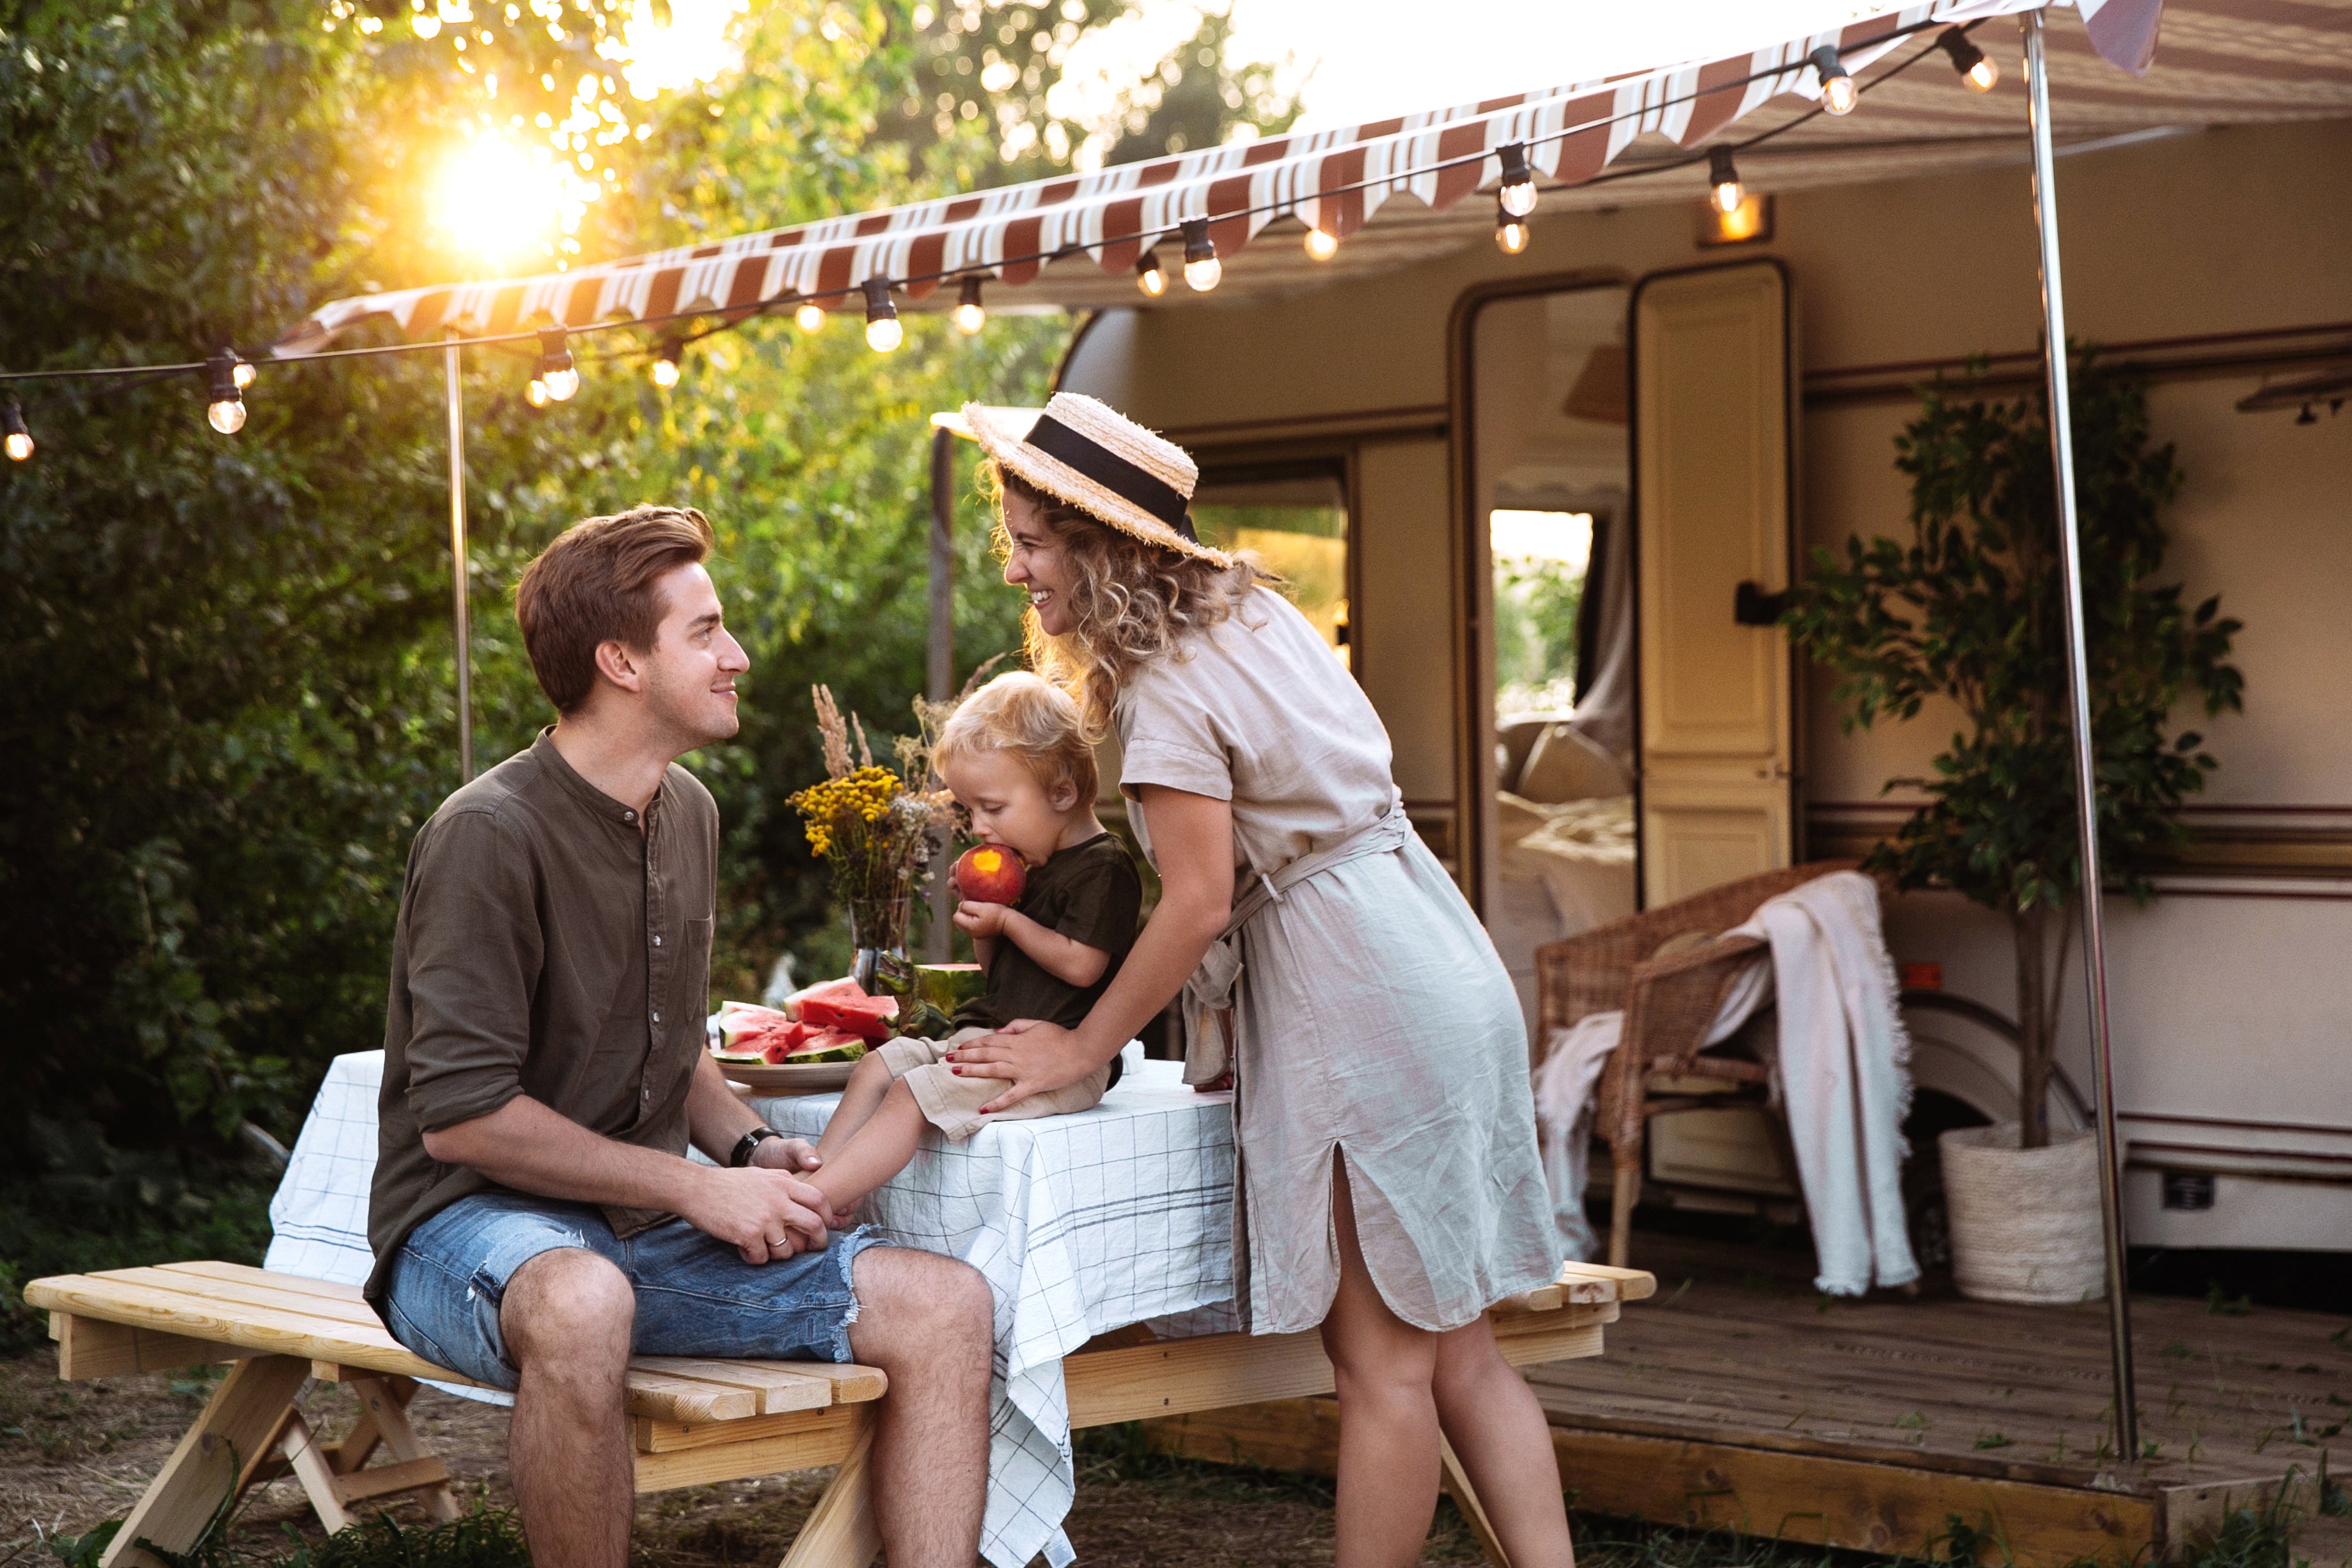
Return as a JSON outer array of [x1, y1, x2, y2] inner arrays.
[[0, 0, 1298, 1152]]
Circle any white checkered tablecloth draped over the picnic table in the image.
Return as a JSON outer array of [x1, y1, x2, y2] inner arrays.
[[266, 1046, 1237, 1568]]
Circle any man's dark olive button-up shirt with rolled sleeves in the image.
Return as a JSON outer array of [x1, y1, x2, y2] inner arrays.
[[367, 733, 719, 1312]]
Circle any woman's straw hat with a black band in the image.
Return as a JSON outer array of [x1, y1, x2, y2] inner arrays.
[[931, 393, 1232, 567]]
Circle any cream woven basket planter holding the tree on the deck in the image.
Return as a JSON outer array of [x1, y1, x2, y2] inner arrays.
[[1936, 1122, 2107, 1307]]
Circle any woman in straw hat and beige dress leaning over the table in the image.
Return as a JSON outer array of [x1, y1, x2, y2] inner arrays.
[[950, 393, 1574, 1568]]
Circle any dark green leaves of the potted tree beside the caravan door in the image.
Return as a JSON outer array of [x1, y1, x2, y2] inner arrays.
[[1785, 352, 2241, 912]]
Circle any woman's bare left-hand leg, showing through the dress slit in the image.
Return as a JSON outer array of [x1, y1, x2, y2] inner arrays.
[[1322, 1154, 1437, 1568]]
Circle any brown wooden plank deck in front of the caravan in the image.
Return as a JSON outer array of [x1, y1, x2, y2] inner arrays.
[[1155, 1234, 2352, 1565]]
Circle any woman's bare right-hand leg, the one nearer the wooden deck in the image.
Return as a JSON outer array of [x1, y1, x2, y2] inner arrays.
[[1430, 1314, 1576, 1568]]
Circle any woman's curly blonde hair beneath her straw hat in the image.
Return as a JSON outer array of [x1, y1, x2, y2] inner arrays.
[[983, 463, 1280, 743]]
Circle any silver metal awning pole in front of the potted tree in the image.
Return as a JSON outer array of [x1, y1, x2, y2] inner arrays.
[[2023, 12, 2140, 1464]]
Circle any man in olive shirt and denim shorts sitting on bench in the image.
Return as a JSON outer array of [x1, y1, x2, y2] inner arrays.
[[367, 505, 990, 1568]]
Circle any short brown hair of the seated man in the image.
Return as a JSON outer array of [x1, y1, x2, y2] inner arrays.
[[515, 505, 715, 712]]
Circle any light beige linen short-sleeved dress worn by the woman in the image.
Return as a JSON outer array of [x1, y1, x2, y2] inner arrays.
[[1117, 588, 1562, 1333]]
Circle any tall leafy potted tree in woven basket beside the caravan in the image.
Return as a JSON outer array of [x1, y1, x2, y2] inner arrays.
[[1783, 350, 2241, 1300]]
